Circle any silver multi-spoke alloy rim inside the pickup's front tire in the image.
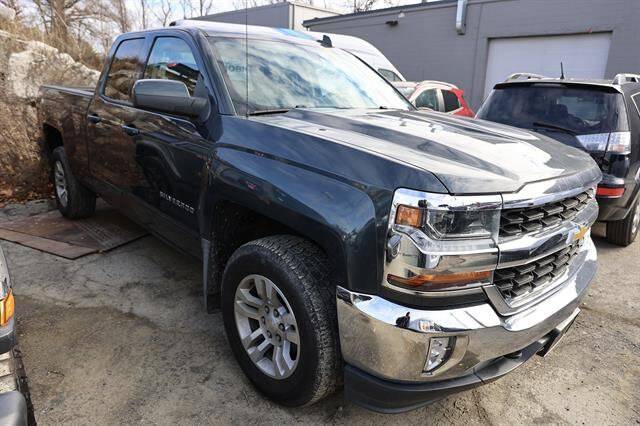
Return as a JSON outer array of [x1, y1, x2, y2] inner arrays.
[[234, 275, 300, 380]]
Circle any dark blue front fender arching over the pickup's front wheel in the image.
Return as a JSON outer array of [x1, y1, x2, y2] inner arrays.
[[200, 148, 382, 292]]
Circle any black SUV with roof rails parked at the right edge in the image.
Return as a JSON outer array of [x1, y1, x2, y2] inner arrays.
[[477, 74, 640, 246]]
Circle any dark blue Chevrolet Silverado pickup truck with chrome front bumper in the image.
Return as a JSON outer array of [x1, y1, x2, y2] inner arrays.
[[38, 21, 601, 412]]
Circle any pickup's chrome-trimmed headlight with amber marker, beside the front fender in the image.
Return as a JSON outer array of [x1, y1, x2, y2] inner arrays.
[[383, 189, 502, 293]]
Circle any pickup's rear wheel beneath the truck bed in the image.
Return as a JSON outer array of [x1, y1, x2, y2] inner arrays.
[[52, 146, 96, 219]]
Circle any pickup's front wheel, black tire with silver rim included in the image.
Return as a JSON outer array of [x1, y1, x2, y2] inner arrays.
[[222, 235, 341, 406]]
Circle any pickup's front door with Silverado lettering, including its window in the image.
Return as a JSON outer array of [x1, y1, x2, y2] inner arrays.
[[128, 32, 212, 254]]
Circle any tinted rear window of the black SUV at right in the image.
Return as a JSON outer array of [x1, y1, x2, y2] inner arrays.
[[477, 84, 628, 135]]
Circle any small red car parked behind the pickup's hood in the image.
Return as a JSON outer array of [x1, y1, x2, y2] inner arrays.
[[393, 80, 474, 117]]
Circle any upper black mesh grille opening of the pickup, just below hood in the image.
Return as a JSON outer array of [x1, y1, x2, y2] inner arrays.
[[500, 191, 591, 237]]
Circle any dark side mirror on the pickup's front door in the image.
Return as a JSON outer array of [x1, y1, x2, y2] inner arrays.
[[133, 79, 209, 117]]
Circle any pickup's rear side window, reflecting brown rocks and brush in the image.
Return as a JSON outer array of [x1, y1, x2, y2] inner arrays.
[[104, 38, 144, 101]]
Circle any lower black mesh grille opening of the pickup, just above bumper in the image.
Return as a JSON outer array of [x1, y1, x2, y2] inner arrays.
[[493, 240, 583, 300]]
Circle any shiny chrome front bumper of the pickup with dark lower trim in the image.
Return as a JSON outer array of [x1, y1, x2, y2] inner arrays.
[[337, 238, 597, 412]]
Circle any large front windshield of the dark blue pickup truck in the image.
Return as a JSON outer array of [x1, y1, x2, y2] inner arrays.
[[209, 38, 411, 114]]
